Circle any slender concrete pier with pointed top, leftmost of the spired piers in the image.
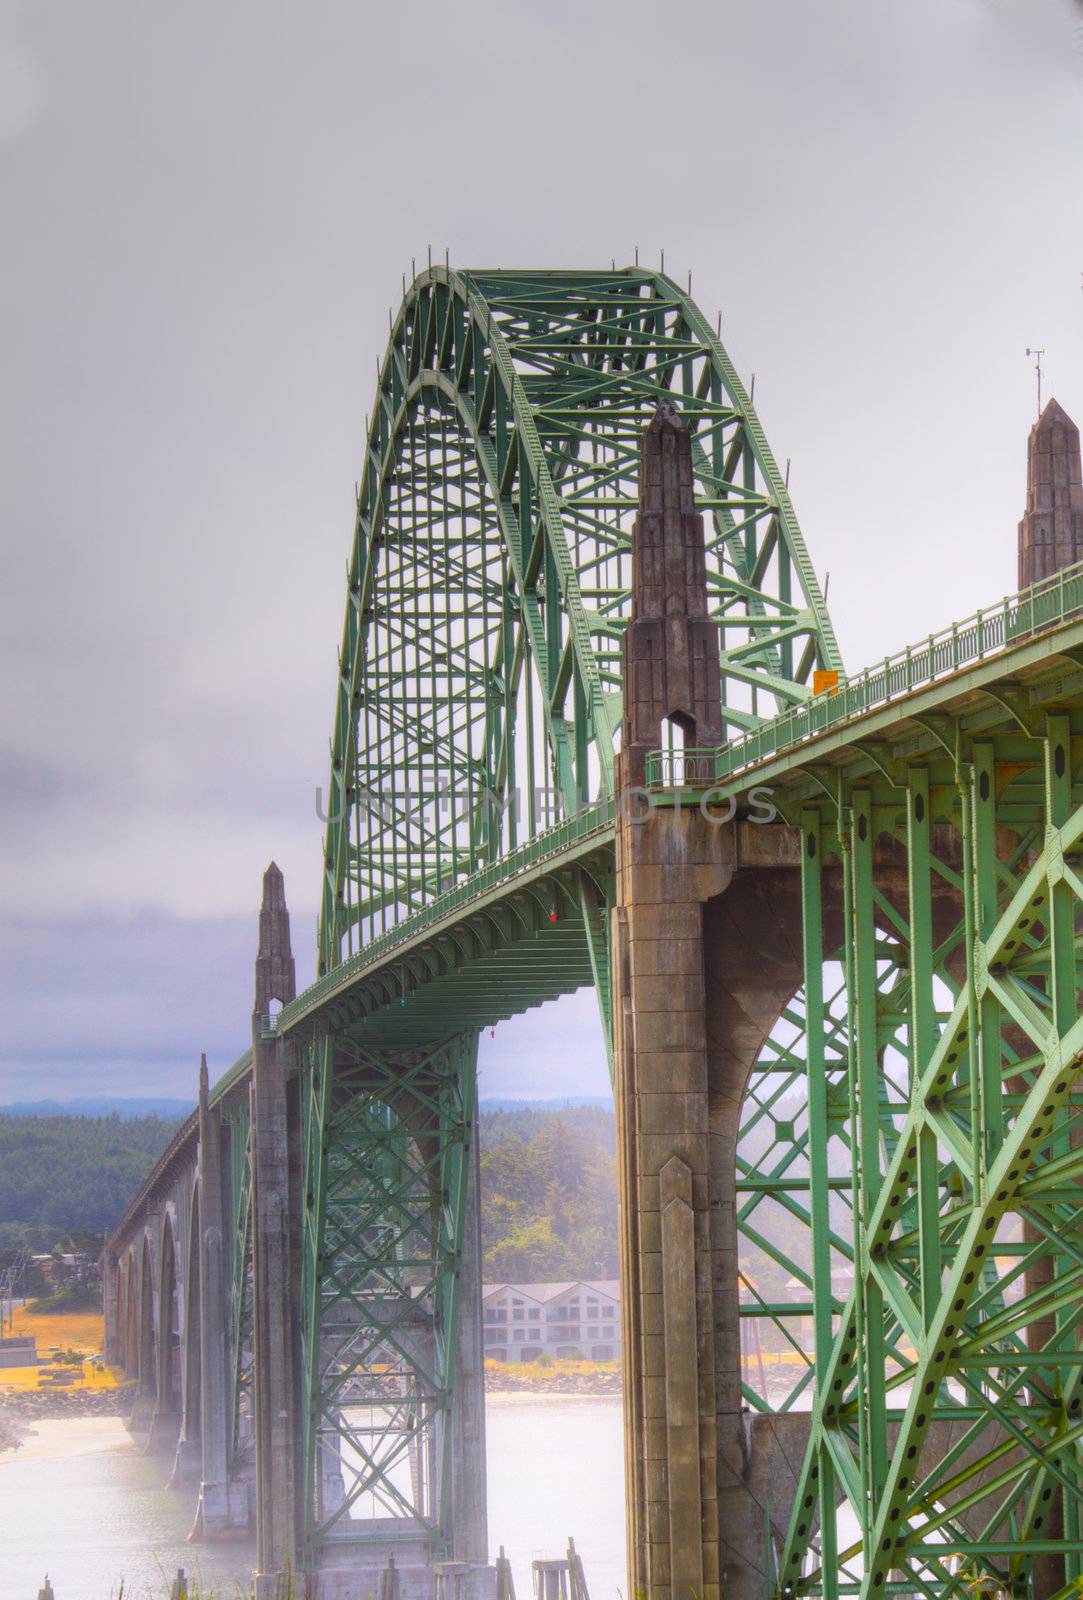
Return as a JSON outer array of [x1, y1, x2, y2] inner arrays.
[[194, 1056, 229, 1539]]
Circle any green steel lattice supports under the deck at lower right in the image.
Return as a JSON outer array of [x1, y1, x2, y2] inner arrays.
[[761, 712, 1083, 1597]]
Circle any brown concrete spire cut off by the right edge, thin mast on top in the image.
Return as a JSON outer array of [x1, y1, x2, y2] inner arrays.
[[1019, 400, 1083, 589]]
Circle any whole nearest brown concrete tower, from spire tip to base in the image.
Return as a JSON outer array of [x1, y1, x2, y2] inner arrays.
[[613, 405, 801, 1600]]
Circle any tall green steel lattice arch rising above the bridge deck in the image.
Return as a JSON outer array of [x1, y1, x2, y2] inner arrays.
[[311, 267, 840, 974]]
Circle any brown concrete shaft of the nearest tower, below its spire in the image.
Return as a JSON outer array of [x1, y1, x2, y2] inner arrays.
[[613, 814, 729, 1600]]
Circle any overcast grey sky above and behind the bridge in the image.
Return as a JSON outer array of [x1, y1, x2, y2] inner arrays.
[[0, 0, 1083, 1102]]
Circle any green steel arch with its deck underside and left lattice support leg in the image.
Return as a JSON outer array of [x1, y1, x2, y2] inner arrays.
[[294, 267, 840, 1562]]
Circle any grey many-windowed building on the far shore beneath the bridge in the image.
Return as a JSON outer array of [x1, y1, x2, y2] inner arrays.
[[482, 1278, 621, 1362]]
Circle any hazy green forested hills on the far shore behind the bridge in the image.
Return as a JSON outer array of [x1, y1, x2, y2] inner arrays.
[[0, 1106, 617, 1280]]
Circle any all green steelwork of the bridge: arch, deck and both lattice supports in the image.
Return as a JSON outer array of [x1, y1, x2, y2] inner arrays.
[[278, 269, 1083, 1600]]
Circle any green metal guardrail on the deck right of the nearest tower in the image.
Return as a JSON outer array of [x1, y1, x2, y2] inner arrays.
[[646, 562, 1083, 787]]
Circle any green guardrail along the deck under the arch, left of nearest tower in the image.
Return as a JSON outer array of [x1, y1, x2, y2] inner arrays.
[[276, 800, 613, 1034]]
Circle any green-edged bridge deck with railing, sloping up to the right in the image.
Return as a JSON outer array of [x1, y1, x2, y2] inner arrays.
[[147, 553, 1083, 1113]]
